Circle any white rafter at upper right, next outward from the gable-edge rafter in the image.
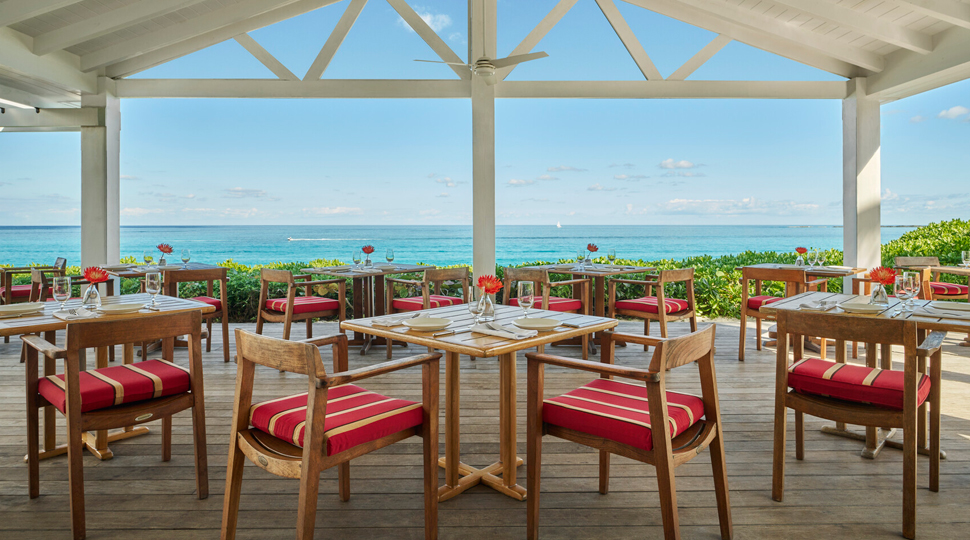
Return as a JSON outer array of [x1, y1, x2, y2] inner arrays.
[[773, 0, 933, 54]]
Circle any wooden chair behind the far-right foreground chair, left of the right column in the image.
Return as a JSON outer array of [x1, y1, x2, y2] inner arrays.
[[738, 267, 828, 362]]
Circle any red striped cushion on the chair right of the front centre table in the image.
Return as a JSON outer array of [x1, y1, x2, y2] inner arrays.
[[542, 379, 704, 451]]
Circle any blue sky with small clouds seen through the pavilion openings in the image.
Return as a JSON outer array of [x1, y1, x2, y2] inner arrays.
[[0, 0, 970, 225]]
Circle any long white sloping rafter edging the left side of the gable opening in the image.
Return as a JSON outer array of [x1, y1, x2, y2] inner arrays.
[[105, 0, 339, 78]]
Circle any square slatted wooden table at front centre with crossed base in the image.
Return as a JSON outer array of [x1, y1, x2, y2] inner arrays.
[[340, 305, 619, 501]]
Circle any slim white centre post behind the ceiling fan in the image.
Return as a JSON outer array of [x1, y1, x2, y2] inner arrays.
[[468, 0, 495, 280]]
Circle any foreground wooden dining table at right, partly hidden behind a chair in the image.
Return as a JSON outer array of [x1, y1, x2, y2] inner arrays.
[[761, 292, 970, 459]]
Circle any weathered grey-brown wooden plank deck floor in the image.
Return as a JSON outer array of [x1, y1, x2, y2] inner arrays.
[[0, 321, 970, 540]]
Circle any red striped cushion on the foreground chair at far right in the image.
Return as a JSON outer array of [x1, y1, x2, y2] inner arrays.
[[788, 358, 930, 409]]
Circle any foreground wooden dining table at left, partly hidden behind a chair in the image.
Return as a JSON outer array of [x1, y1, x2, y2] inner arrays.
[[0, 293, 215, 460]]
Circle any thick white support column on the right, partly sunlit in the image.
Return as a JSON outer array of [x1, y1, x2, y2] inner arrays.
[[842, 77, 882, 292]]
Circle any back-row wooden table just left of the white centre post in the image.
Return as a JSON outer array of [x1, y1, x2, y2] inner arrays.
[[300, 263, 424, 354]]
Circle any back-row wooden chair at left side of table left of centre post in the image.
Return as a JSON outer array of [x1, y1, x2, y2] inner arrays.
[[256, 268, 347, 339]]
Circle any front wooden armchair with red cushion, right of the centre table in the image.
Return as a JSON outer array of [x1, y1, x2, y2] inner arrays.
[[525, 324, 733, 540]]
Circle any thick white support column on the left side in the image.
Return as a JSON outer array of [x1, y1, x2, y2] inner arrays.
[[81, 77, 121, 266]]
